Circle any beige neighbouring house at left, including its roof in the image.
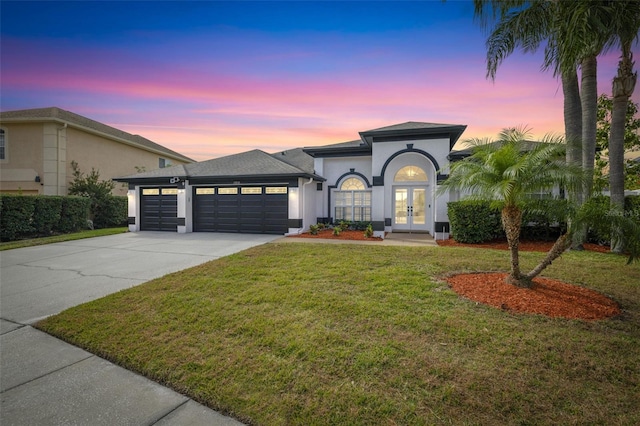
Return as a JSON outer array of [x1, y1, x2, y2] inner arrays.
[[0, 107, 193, 195]]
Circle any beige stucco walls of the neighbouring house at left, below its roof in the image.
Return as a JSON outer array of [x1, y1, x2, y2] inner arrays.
[[0, 122, 190, 195]]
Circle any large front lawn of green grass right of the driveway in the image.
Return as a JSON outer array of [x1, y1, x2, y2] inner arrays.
[[38, 243, 640, 425]]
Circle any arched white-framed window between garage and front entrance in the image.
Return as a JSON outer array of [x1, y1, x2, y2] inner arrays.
[[334, 177, 371, 222]]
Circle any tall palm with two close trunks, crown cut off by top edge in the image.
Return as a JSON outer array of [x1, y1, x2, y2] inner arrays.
[[475, 0, 611, 248]]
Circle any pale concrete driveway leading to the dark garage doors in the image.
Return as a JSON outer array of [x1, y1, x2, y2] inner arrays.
[[0, 232, 280, 324]]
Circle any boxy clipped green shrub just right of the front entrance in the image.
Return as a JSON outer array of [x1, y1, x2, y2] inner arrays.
[[447, 200, 504, 244]]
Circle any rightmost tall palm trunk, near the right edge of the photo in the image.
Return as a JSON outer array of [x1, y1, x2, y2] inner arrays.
[[609, 45, 638, 253]]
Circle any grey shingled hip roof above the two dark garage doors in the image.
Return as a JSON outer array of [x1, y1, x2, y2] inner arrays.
[[114, 148, 324, 182]]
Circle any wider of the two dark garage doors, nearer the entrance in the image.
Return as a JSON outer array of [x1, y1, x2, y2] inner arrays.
[[193, 185, 289, 234]]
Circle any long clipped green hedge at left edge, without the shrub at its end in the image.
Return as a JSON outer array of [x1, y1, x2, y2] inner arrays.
[[0, 194, 90, 241]]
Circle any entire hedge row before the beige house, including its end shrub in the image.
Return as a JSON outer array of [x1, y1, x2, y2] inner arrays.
[[0, 194, 127, 241]]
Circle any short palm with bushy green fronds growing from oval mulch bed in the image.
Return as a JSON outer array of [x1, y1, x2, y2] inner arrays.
[[438, 128, 583, 287]]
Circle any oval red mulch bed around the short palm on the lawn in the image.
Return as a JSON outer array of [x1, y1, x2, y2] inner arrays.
[[446, 273, 620, 320]]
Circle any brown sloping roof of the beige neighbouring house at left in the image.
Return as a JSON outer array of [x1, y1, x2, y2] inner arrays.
[[0, 107, 194, 163]]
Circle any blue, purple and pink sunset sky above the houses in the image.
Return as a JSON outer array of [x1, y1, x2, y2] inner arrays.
[[0, 0, 640, 160]]
